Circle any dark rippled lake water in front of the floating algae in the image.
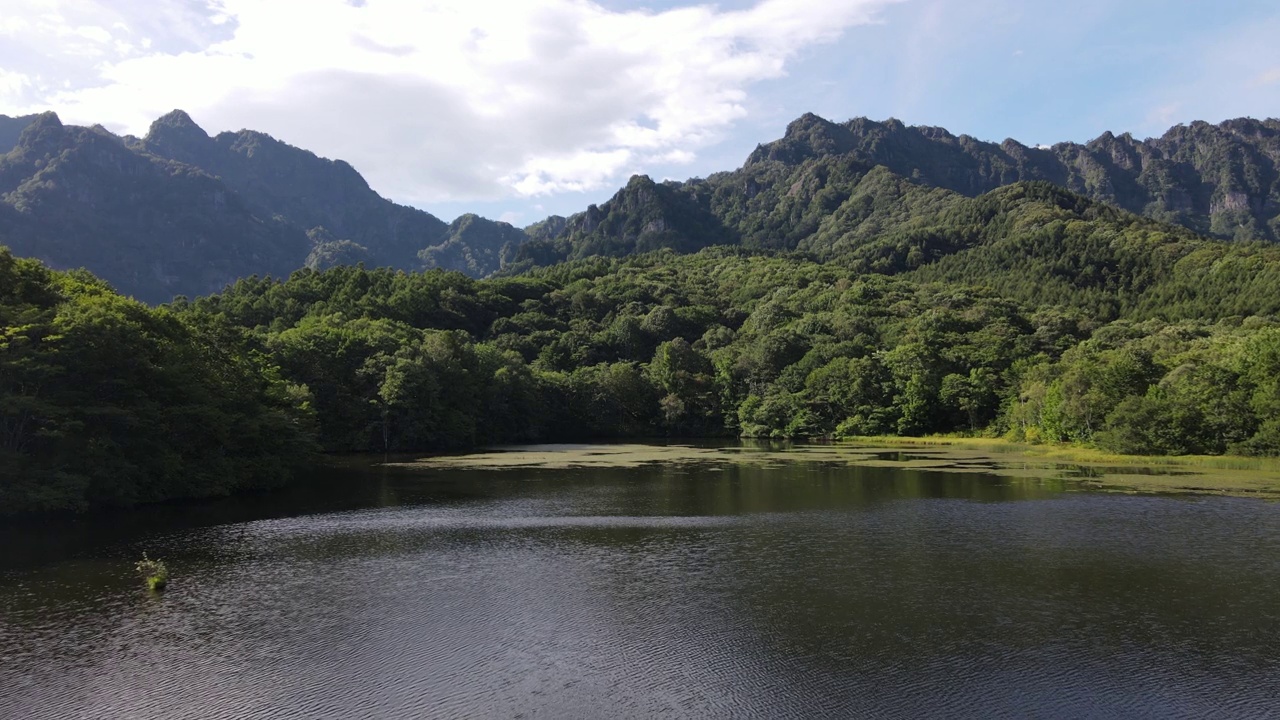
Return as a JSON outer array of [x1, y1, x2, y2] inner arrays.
[[0, 445, 1280, 720]]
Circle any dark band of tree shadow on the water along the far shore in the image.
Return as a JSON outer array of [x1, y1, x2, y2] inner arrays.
[[0, 456, 1066, 570]]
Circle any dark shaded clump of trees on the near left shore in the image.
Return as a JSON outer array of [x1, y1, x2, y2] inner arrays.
[[0, 247, 315, 512]]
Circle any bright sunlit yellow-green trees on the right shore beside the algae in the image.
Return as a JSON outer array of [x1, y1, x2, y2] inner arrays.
[[1000, 316, 1280, 455]]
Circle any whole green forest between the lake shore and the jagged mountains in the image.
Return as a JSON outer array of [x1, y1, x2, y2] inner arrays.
[[0, 175, 1280, 511]]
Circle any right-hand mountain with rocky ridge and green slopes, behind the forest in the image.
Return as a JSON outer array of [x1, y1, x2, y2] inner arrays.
[[513, 114, 1280, 268]]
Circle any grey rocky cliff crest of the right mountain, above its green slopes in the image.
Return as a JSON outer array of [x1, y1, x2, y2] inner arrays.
[[746, 114, 1280, 241]]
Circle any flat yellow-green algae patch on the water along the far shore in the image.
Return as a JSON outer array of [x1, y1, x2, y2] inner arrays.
[[388, 443, 1280, 498]]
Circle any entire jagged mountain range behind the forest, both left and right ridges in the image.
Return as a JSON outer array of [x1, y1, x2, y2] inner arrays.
[[0, 110, 1280, 302]]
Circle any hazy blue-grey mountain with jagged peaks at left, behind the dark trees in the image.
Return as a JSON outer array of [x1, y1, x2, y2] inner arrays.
[[0, 110, 501, 302]]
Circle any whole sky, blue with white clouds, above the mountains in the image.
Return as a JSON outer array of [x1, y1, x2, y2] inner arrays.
[[0, 0, 1280, 227]]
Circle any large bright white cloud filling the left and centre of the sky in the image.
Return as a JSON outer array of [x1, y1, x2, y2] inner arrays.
[[0, 0, 893, 204]]
